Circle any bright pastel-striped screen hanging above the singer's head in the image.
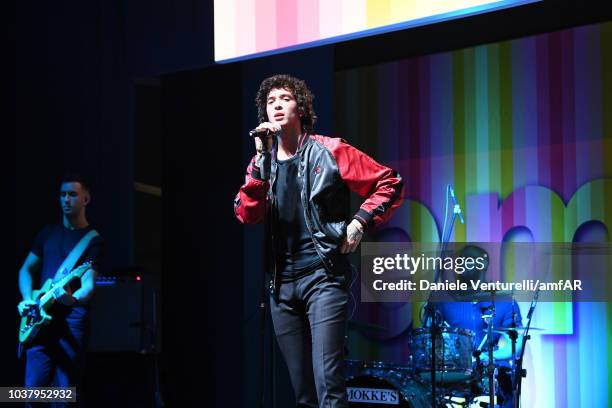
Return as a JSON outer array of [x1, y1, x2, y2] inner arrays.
[[214, 0, 535, 61]]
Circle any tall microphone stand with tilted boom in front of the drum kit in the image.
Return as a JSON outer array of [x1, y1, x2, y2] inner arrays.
[[423, 184, 465, 408]]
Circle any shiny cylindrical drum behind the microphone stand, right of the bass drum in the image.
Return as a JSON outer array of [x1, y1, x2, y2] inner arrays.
[[410, 327, 474, 383]]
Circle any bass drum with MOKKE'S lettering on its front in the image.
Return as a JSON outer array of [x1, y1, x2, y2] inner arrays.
[[345, 360, 429, 408]]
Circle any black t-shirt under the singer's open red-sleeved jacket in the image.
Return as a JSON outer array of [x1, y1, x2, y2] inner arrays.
[[275, 154, 322, 281]]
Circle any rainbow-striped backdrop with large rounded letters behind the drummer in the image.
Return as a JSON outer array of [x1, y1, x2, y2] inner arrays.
[[334, 23, 612, 407]]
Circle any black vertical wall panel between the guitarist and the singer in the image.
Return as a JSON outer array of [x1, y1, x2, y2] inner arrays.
[[162, 62, 243, 406]]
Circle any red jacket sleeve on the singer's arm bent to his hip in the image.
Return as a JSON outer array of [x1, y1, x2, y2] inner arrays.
[[326, 138, 404, 228]]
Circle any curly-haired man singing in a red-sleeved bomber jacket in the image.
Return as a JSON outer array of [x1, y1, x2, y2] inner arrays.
[[234, 75, 403, 407]]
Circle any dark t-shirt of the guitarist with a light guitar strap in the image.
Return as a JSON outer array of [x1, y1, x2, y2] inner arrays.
[[31, 224, 104, 316]]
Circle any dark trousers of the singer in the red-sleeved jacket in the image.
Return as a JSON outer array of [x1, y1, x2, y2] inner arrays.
[[270, 268, 350, 408]]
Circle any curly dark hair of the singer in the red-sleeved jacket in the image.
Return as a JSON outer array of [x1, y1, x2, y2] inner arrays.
[[255, 74, 317, 133]]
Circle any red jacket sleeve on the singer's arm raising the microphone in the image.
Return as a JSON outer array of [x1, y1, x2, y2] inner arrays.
[[234, 156, 268, 224]]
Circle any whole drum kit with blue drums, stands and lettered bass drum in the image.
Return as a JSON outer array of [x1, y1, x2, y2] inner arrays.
[[345, 291, 542, 408]]
